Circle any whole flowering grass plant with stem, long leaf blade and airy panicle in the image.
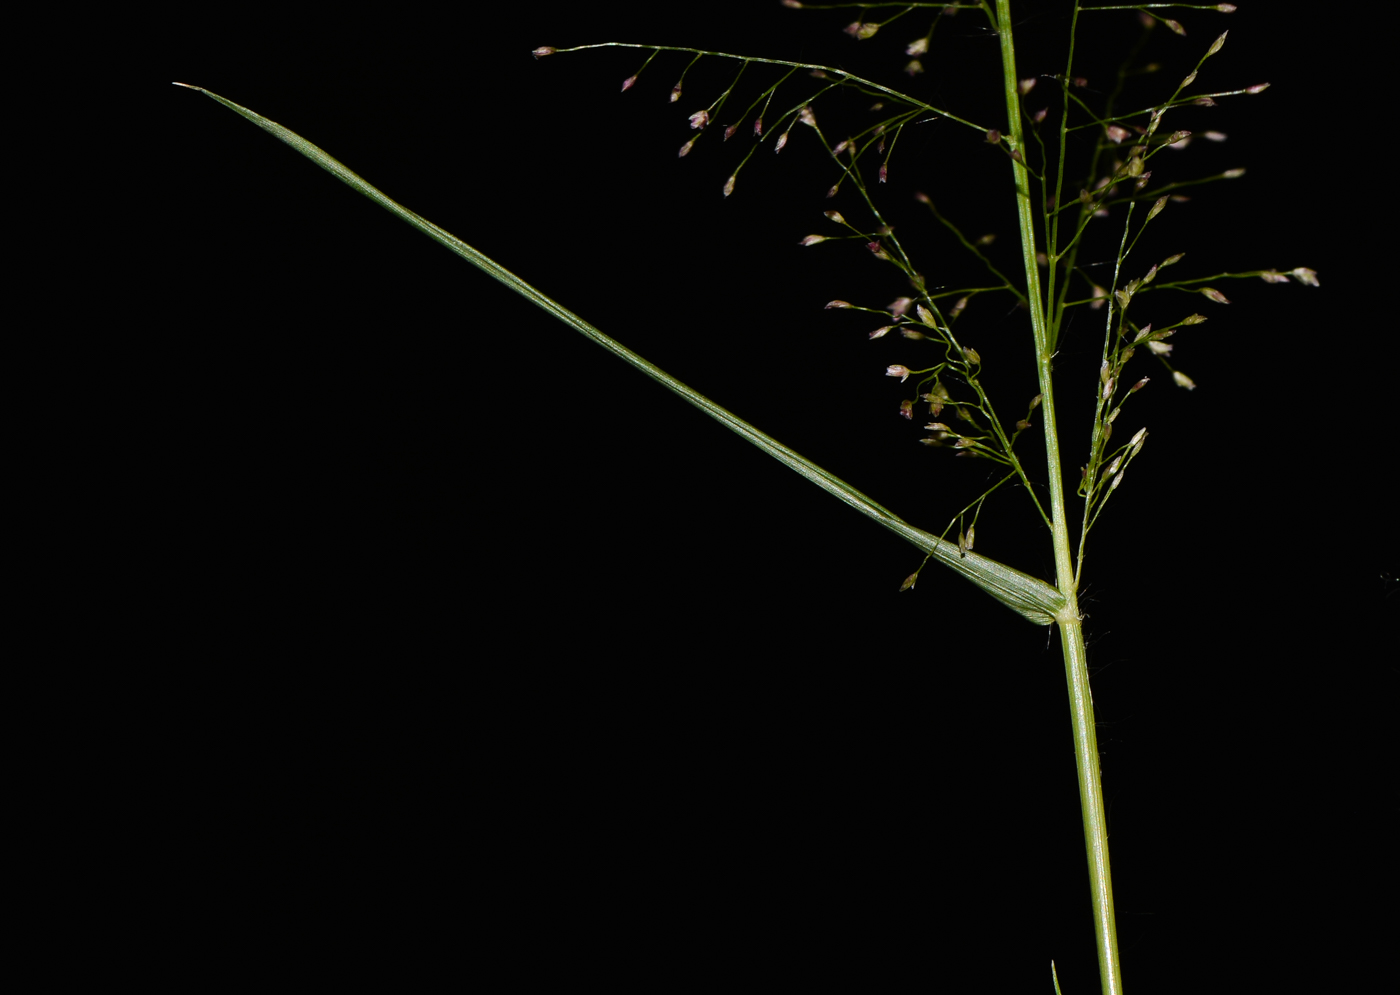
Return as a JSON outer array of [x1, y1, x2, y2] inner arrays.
[[179, 0, 1319, 994]]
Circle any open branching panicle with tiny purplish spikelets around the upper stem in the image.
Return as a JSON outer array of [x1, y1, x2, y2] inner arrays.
[[535, 0, 1319, 589]]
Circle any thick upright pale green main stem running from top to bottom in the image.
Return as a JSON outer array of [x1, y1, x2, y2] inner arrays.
[[997, 0, 1123, 995]]
